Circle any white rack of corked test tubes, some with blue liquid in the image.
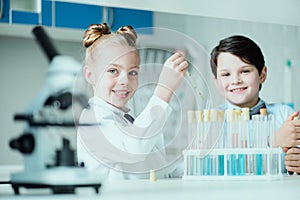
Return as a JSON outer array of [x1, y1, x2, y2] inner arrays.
[[183, 109, 283, 180]]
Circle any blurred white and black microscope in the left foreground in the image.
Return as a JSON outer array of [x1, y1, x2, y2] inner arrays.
[[9, 26, 101, 194]]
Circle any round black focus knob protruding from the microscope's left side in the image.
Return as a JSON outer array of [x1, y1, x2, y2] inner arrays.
[[9, 133, 34, 154]]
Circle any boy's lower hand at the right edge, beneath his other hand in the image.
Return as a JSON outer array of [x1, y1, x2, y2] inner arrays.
[[284, 148, 300, 174]]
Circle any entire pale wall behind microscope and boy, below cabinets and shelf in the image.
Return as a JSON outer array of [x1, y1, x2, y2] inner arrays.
[[0, 10, 300, 165]]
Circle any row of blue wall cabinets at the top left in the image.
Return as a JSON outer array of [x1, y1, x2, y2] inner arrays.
[[0, 0, 153, 31]]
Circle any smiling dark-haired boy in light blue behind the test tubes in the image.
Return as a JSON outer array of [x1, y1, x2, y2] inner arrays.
[[210, 35, 300, 173]]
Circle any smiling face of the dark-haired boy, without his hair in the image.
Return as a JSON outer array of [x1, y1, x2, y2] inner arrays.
[[215, 53, 267, 108]]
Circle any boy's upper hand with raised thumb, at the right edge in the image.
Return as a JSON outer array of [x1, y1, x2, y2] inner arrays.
[[276, 111, 300, 147]]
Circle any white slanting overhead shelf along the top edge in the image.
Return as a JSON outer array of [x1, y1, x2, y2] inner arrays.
[[58, 0, 300, 26]]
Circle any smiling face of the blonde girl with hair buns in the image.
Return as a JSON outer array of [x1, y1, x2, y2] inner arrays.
[[85, 45, 140, 108]]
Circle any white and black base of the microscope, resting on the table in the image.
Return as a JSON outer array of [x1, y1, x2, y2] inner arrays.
[[11, 167, 101, 195]]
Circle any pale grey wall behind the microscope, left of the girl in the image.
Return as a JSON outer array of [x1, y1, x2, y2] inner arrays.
[[0, 36, 83, 165]]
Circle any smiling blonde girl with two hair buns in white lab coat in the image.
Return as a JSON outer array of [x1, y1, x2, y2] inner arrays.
[[77, 23, 188, 179]]
